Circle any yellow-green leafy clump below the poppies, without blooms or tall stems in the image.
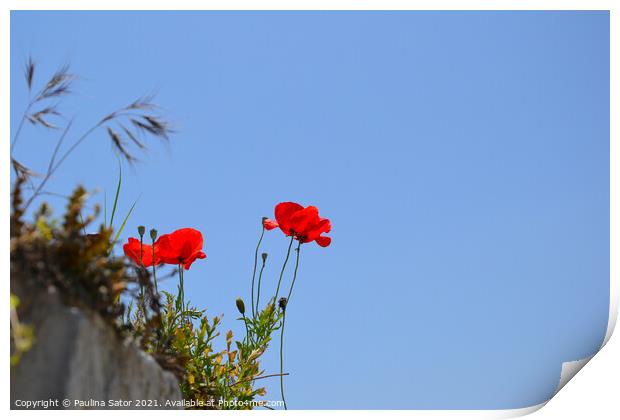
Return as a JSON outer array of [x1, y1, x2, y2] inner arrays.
[[127, 284, 281, 409]]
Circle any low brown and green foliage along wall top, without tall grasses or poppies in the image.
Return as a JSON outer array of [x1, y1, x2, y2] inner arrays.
[[11, 178, 281, 409]]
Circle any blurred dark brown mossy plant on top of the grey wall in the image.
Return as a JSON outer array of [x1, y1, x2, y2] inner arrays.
[[11, 179, 137, 324]]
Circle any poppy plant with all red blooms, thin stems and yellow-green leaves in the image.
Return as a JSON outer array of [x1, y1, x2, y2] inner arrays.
[[123, 202, 331, 408]]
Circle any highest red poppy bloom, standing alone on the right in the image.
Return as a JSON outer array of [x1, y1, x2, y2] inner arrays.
[[275, 202, 332, 247]]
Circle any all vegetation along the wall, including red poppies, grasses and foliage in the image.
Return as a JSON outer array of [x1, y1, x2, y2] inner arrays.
[[11, 60, 331, 409]]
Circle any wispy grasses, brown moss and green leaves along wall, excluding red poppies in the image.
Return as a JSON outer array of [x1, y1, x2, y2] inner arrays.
[[10, 60, 283, 409]]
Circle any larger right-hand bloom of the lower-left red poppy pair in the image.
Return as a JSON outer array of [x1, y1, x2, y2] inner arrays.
[[155, 228, 207, 270]]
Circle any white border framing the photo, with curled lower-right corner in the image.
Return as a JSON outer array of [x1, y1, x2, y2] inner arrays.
[[0, 0, 620, 419]]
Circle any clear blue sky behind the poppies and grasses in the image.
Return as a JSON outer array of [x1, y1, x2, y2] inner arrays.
[[11, 12, 609, 409]]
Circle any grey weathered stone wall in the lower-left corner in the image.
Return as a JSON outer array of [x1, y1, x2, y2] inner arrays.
[[11, 289, 182, 409]]
